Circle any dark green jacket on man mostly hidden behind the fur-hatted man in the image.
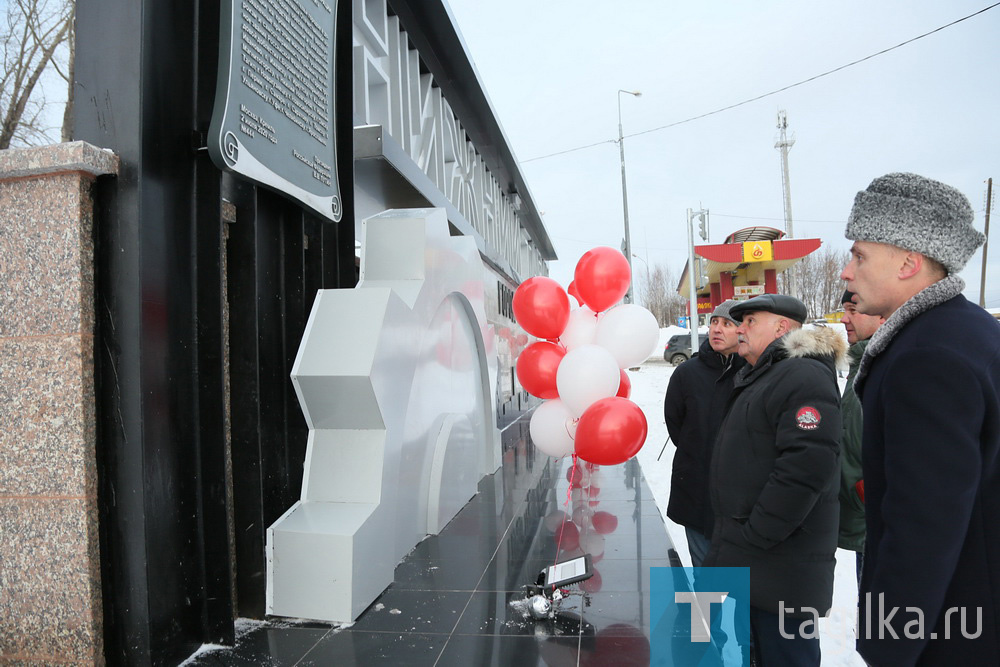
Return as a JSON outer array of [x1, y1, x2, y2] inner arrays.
[[837, 340, 868, 552]]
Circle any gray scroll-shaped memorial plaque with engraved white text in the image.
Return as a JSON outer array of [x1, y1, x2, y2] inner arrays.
[[208, 0, 343, 221]]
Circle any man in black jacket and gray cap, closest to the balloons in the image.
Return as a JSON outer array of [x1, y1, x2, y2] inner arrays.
[[663, 299, 745, 567]]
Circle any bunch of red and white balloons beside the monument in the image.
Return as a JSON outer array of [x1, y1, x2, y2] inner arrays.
[[513, 247, 660, 465]]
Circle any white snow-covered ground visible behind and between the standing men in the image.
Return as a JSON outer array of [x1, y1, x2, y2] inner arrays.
[[627, 352, 865, 667]]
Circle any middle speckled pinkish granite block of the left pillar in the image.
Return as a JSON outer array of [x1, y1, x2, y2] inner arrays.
[[0, 335, 97, 496]]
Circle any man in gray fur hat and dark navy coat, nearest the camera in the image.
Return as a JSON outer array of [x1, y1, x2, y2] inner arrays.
[[841, 173, 1000, 667]]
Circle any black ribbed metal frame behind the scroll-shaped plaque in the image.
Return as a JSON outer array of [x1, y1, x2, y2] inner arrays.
[[74, 0, 357, 665]]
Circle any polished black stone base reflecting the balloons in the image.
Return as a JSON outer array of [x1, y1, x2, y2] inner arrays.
[[188, 419, 676, 667]]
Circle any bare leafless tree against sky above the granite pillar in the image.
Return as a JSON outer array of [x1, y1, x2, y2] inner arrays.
[[0, 0, 76, 149]]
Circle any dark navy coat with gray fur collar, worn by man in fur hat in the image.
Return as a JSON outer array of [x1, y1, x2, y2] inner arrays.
[[856, 288, 1000, 667]]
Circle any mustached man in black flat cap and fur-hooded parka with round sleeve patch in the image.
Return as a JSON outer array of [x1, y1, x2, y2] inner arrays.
[[705, 294, 847, 667]]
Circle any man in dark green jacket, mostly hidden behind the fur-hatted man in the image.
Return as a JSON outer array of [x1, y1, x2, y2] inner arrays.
[[837, 290, 885, 584]]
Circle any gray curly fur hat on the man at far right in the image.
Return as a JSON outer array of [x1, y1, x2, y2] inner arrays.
[[844, 173, 986, 274]]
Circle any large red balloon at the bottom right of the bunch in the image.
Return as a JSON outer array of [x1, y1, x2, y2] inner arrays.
[[576, 396, 648, 466]]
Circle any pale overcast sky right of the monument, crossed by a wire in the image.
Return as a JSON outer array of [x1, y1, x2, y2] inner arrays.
[[447, 0, 1000, 307]]
